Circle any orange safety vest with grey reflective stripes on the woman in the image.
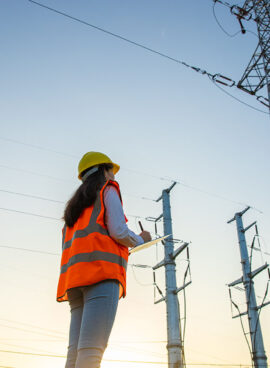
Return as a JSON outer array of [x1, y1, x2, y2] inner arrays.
[[57, 180, 128, 302]]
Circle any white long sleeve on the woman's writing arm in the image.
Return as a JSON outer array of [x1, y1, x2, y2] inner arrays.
[[104, 186, 144, 247]]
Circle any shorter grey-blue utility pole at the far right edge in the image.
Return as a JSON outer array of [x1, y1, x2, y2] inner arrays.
[[228, 207, 269, 368]]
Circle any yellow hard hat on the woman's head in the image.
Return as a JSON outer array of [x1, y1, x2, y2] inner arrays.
[[78, 151, 120, 179]]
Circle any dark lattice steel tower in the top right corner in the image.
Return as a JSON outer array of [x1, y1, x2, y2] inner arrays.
[[237, 0, 270, 108]]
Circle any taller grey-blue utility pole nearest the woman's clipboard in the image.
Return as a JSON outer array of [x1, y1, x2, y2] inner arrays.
[[153, 182, 191, 368]]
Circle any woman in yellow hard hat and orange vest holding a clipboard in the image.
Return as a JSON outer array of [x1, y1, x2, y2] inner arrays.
[[57, 152, 151, 368]]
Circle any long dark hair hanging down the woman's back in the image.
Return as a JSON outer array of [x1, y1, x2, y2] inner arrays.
[[63, 164, 113, 227]]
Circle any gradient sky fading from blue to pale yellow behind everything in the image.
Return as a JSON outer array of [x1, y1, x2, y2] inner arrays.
[[0, 0, 270, 368]]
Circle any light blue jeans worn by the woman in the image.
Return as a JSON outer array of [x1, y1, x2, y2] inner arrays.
[[65, 280, 119, 368]]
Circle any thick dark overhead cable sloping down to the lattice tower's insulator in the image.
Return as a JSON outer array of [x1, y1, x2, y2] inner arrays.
[[28, 0, 270, 110]]
